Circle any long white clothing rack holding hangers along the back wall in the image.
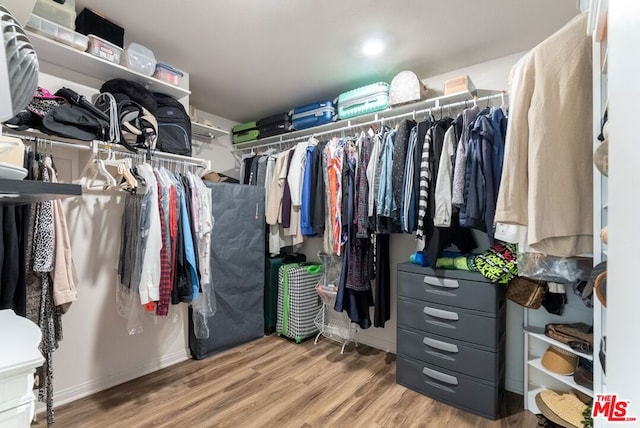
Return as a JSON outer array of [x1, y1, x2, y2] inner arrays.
[[233, 91, 508, 152]]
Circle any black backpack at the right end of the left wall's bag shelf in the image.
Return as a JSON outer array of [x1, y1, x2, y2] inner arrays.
[[154, 94, 191, 156]]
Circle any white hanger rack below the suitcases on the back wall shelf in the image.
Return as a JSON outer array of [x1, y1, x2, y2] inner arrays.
[[233, 91, 508, 152]]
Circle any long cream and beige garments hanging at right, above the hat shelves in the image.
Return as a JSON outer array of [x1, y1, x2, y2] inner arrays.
[[495, 14, 593, 257]]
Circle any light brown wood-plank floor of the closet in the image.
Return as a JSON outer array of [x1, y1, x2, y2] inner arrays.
[[34, 336, 537, 428]]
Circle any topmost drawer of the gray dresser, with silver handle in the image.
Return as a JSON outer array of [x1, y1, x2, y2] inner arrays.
[[398, 271, 504, 313]]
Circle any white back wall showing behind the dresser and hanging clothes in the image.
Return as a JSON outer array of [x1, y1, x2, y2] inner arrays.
[[301, 52, 524, 393]]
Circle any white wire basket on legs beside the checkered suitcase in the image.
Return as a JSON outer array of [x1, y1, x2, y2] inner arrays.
[[314, 254, 358, 354]]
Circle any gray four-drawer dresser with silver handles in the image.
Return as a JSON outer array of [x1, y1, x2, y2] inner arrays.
[[396, 263, 506, 420]]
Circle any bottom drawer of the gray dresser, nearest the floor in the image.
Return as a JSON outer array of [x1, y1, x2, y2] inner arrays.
[[396, 355, 502, 420]]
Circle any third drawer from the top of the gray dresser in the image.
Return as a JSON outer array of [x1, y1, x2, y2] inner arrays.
[[397, 328, 504, 383]]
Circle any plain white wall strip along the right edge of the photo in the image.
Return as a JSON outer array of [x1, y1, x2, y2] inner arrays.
[[605, 0, 640, 420]]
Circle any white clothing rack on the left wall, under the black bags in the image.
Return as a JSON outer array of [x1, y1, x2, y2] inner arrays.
[[2, 130, 211, 170]]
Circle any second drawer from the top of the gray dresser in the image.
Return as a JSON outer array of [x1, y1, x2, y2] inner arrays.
[[398, 297, 505, 349]]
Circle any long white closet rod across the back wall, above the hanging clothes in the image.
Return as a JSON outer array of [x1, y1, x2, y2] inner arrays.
[[233, 92, 508, 152]]
